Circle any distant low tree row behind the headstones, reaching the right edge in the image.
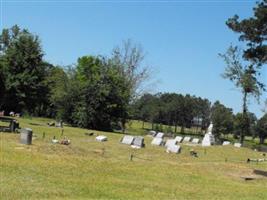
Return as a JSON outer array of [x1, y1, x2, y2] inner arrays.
[[132, 93, 267, 143]]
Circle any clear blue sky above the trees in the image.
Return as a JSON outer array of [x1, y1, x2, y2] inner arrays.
[[1, 0, 267, 117]]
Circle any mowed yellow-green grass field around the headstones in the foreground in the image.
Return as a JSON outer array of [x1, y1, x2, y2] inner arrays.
[[0, 118, 267, 200]]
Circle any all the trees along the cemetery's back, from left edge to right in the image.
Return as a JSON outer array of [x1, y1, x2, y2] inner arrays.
[[0, 0, 267, 143]]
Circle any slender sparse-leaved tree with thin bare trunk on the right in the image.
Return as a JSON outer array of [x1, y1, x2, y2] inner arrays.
[[220, 46, 264, 143]]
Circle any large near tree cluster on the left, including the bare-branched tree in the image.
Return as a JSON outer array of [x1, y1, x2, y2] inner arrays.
[[0, 25, 148, 130]]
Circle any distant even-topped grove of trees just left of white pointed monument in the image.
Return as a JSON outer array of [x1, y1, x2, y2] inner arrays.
[[132, 93, 211, 132]]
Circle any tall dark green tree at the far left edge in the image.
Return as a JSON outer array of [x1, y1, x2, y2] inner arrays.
[[0, 26, 45, 113]]
